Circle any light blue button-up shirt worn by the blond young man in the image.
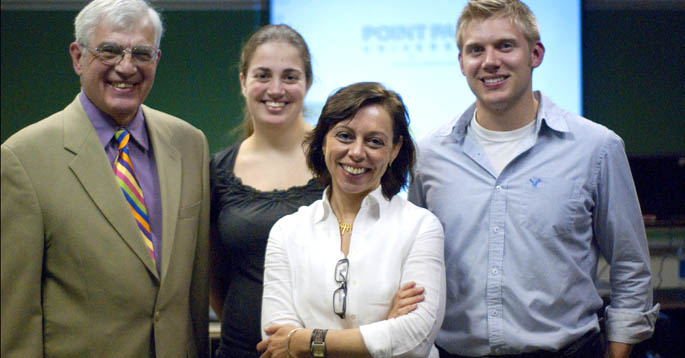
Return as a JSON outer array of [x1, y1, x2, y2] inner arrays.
[[409, 92, 658, 356]]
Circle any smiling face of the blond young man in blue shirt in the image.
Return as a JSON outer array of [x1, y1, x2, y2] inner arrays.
[[459, 16, 544, 111]]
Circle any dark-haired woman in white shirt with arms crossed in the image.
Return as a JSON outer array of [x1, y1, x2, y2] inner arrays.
[[257, 82, 445, 357]]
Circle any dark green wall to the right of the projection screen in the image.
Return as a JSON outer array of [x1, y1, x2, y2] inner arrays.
[[584, 6, 685, 156]]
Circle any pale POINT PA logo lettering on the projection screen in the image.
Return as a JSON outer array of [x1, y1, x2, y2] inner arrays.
[[360, 24, 458, 66]]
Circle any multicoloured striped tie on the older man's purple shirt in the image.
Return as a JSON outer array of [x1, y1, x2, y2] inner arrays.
[[114, 128, 155, 260]]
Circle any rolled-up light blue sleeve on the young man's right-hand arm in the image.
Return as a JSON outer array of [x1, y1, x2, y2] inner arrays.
[[593, 132, 659, 344]]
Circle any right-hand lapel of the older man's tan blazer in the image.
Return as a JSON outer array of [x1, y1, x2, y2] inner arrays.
[[143, 106, 182, 280]]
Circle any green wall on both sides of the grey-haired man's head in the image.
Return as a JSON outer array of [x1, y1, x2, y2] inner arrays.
[[1, 10, 268, 152]]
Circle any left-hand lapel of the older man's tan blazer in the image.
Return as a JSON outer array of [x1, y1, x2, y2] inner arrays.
[[64, 96, 159, 279]]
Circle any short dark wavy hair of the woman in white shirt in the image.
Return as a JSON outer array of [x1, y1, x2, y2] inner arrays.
[[304, 82, 416, 199]]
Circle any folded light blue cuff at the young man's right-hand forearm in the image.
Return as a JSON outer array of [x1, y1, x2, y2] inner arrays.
[[604, 303, 660, 344]]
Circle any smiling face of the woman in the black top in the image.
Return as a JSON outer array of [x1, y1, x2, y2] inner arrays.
[[240, 42, 307, 130]]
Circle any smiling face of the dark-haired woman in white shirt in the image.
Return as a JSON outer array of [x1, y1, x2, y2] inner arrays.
[[324, 104, 402, 200]]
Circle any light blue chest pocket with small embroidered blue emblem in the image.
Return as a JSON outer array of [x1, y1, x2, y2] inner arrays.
[[519, 177, 582, 238]]
